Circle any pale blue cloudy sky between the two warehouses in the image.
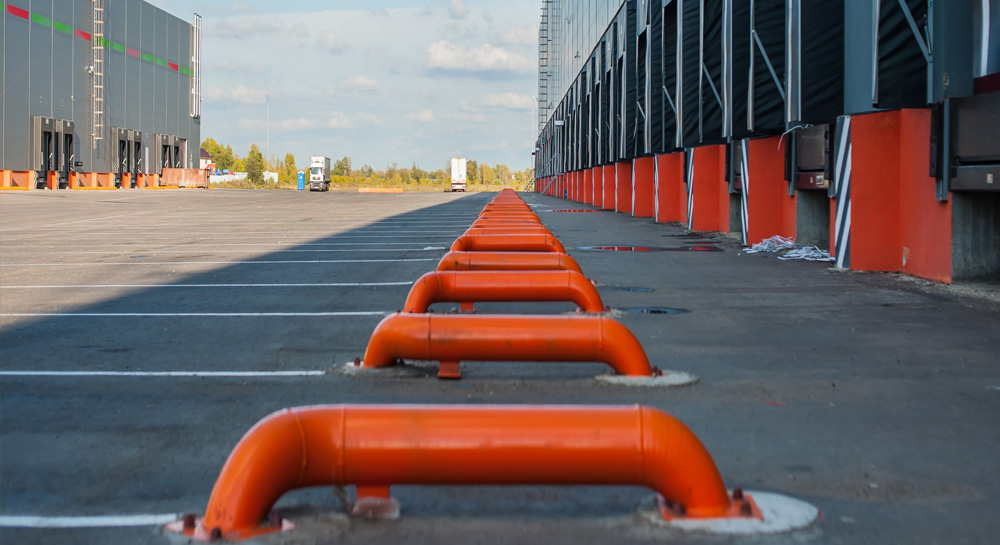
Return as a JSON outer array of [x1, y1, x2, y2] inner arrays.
[[153, 0, 539, 170]]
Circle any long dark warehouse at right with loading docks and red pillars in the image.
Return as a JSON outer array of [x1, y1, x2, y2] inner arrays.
[[535, 0, 1000, 282]]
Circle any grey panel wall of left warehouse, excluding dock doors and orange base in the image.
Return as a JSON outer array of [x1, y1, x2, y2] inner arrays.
[[0, 0, 201, 172]]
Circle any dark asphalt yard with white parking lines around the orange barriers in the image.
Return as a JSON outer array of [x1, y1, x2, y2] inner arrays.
[[0, 189, 1000, 545]]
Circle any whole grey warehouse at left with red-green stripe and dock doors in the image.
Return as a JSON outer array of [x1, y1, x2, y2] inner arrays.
[[0, 0, 201, 188]]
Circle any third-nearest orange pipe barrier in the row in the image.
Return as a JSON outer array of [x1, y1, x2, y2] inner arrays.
[[403, 271, 604, 313]]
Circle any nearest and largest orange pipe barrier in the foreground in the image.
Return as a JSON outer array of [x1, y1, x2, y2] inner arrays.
[[176, 405, 748, 541]]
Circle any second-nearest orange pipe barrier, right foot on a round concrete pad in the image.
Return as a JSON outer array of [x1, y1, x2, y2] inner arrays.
[[363, 312, 653, 378]]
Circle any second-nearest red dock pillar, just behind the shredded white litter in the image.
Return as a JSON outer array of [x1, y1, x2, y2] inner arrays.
[[743, 136, 795, 244]]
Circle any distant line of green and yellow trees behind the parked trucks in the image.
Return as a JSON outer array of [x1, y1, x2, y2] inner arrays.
[[201, 138, 535, 190]]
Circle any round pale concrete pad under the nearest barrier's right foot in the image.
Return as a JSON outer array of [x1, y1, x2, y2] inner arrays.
[[640, 491, 819, 535]]
